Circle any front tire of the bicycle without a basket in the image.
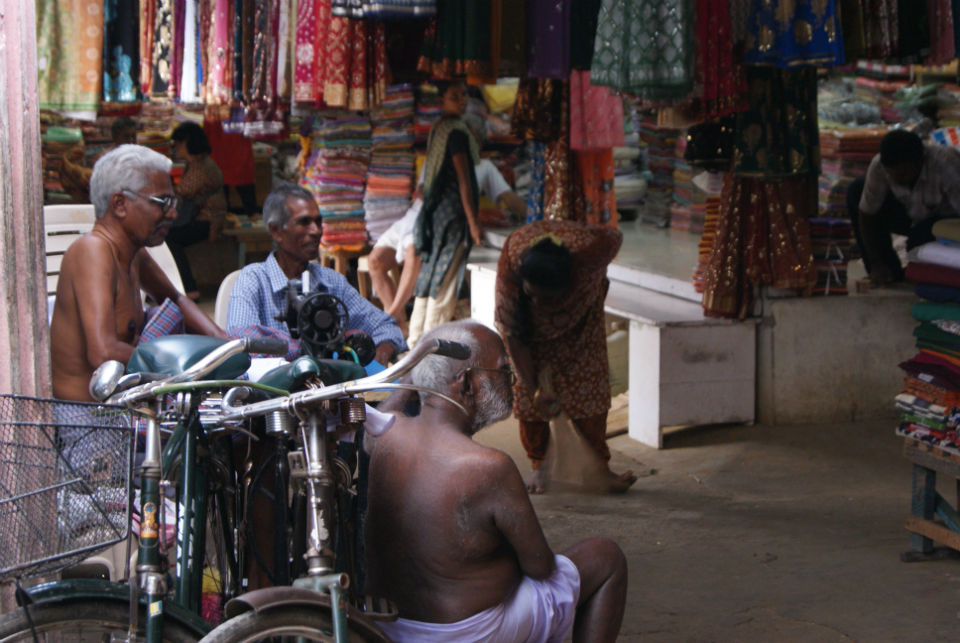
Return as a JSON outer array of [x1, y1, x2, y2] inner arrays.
[[200, 605, 389, 643]]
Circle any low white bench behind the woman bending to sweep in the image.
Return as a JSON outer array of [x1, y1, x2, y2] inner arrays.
[[468, 262, 756, 449]]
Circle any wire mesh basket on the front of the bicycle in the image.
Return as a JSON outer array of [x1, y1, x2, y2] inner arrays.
[[0, 394, 136, 580]]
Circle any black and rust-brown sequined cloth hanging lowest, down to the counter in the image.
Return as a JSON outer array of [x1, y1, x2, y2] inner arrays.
[[703, 66, 820, 319]]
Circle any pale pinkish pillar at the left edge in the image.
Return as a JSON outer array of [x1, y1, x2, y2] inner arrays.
[[0, 0, 50, 396]]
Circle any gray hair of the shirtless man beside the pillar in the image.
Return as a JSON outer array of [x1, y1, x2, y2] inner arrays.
[[90, 145, 173, 219]]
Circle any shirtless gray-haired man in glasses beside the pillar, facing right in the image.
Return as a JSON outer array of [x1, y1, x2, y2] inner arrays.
[[50, 145, 226, 400]]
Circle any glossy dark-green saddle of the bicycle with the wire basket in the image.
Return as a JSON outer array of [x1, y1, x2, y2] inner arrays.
[[127, 335, 250, 380]]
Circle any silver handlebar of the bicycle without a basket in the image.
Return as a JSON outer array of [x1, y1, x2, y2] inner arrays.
[[221, 338, 470, 422]]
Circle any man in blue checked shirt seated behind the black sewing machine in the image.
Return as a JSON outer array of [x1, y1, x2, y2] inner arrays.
[[227, 184, 407, 364]]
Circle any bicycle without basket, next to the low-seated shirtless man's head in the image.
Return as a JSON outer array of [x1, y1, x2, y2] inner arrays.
[[202, 339, 470, 643]]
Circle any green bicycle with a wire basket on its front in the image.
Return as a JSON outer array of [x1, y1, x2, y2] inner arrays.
[[0, 336, 286, 643]]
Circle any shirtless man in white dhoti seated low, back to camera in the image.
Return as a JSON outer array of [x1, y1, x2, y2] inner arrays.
[[366, 321, 627, 641]]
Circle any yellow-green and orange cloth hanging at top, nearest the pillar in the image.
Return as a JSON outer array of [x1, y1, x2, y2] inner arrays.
[[37, 0, 104, 112]]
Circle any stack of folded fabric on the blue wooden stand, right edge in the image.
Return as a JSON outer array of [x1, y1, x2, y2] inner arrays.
[[896, 219, 960, 454]]
